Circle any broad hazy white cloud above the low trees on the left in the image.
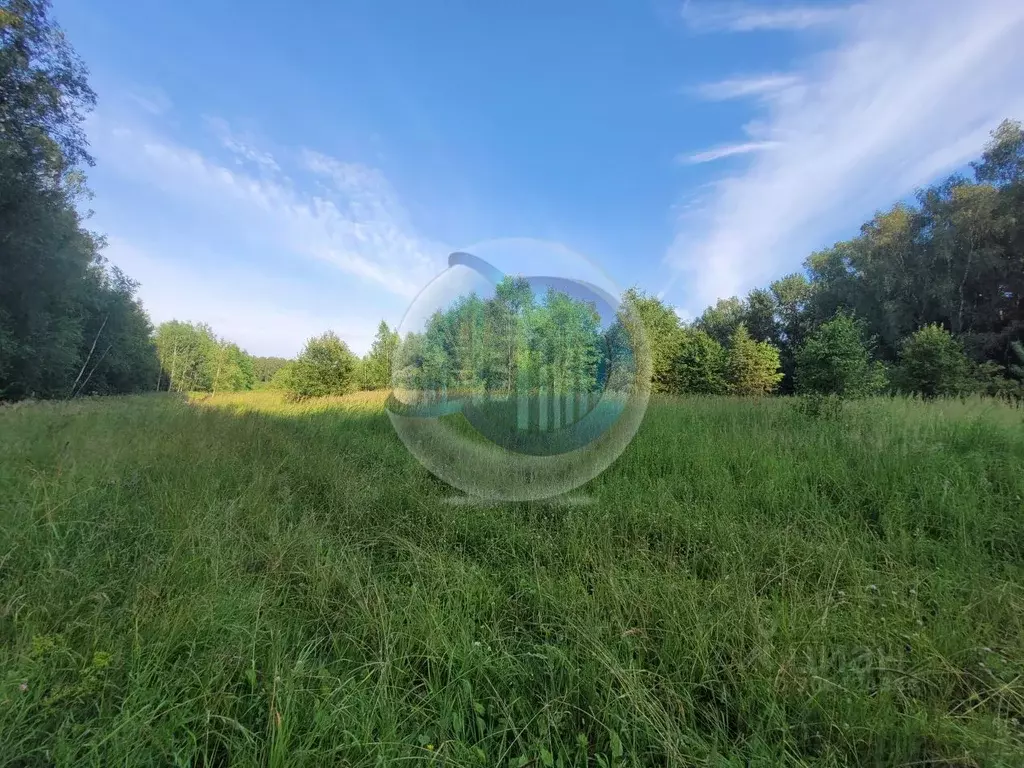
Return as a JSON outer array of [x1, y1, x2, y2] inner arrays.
[[89, 108, 447, 354]]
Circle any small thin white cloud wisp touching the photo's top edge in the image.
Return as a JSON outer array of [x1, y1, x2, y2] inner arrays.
[[682, 0, 855, 32]]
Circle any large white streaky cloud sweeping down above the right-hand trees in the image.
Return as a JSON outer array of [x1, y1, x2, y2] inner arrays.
[[667, 0, 1024, 312]]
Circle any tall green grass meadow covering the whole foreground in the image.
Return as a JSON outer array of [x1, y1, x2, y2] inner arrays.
[[0, 393, 1024, 768]]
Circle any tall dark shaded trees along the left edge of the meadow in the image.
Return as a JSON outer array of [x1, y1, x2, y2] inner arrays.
[[0, 0, 157, 399]]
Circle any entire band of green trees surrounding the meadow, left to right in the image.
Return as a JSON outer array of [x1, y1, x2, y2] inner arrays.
[[0, 0, 1024, 400]]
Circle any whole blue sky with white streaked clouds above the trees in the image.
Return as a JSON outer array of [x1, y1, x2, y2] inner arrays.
[[54, 0, 1024, 355]]
